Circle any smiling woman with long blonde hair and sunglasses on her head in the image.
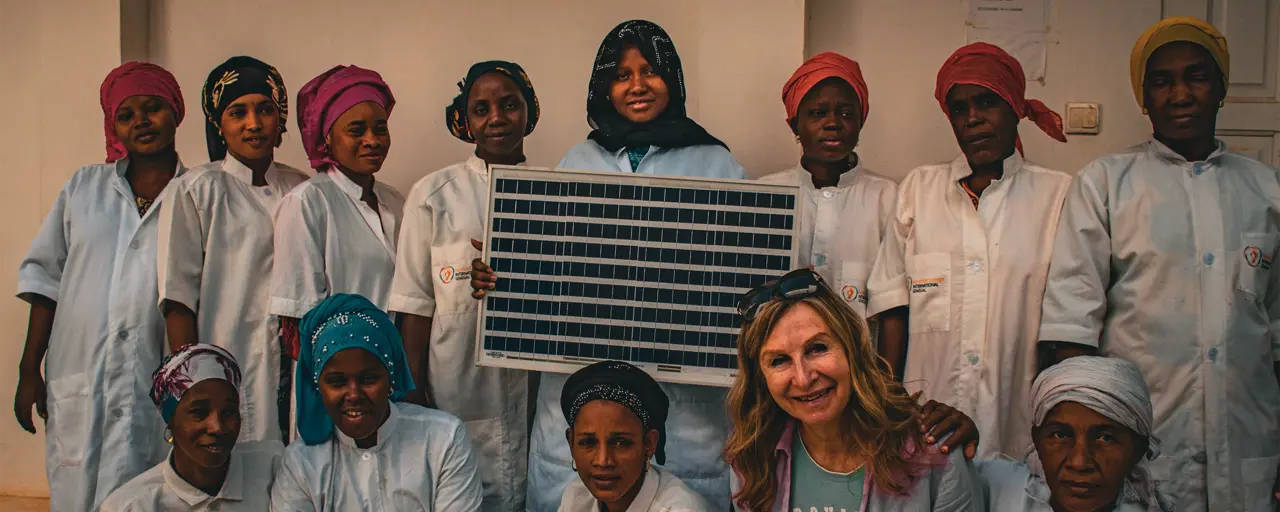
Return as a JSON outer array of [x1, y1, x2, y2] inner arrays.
[[724, 269, 986, 511]]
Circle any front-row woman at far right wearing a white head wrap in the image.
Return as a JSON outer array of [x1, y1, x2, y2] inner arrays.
[[978, 356, 1172, 512]]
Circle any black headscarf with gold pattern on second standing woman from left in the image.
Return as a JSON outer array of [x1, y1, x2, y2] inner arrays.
[[200, 55, 289, 161]]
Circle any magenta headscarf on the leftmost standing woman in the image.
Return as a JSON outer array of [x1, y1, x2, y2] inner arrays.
[[99, 61, 187, 164]]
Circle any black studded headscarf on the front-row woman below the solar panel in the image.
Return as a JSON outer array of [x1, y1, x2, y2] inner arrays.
[[561, 361, 671, 465]]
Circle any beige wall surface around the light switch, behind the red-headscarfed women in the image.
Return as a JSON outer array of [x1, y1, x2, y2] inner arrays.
[[805, 0, 1161, 179]]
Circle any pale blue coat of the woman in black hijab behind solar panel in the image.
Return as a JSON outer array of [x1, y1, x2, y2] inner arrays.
[[524, 141, 746, 512]]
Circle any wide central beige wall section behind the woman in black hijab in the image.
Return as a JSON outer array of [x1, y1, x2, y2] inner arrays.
[[150, 0, 804, 192]]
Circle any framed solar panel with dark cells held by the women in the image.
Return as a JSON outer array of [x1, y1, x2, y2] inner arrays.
[[476, 166, 800, 387]]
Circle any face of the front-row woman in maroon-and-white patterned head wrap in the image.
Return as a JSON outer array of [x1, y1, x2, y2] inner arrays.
[[169, 379, 241, 495]]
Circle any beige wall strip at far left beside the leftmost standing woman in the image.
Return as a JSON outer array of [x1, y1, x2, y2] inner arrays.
[[0, 0, 120, 495]]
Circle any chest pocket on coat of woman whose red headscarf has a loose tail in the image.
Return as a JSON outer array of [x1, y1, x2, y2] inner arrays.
[[906, 252, 952, 333]]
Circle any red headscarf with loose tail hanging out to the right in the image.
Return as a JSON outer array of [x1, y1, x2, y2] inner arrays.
[[933, 42, 1066, 152]]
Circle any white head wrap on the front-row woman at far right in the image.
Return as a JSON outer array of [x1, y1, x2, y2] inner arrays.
[[1027, 356, 1171, 511]]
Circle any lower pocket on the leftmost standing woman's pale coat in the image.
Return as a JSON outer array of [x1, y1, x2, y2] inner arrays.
[[46, 374, 91, 466]]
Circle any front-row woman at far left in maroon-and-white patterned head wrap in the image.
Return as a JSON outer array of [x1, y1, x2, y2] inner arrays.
[[101, 344, 282, 512]]
